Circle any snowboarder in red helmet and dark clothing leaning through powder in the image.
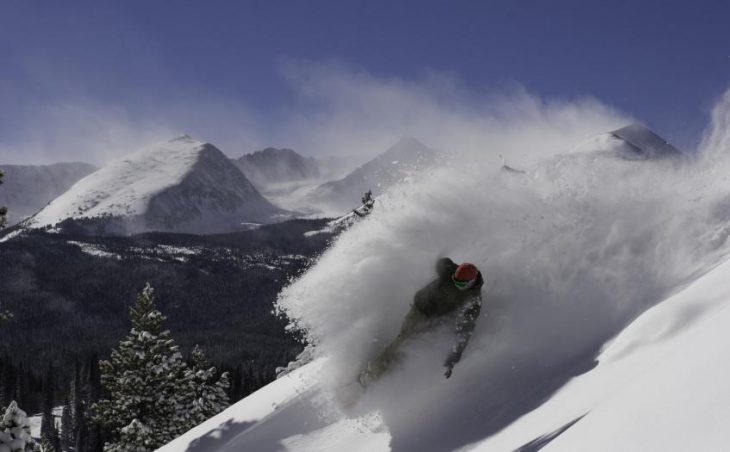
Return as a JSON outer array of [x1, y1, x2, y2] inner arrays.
[[358, 257, 484, 387]]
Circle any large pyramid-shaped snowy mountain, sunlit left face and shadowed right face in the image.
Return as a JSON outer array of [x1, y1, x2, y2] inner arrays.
[[24, 135, 285, 234]]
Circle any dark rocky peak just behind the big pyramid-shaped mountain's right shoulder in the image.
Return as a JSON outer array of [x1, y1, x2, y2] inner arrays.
[[233, 148, 320, 189]]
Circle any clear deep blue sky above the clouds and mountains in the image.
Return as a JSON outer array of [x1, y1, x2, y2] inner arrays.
[[0, 0, 730, 161]]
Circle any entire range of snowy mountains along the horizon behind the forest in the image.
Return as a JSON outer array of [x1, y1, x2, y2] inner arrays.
[[0, 124, 684, 235]]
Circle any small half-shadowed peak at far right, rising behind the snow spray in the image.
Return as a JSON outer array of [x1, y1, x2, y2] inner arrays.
[[576, 124, 685, 160]]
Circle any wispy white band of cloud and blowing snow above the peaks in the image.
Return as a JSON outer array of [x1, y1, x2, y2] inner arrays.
[[0, 60, 625, 164]]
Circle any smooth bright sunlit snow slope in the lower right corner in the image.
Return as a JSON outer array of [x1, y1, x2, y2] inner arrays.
[[469, 252, 730, 452]]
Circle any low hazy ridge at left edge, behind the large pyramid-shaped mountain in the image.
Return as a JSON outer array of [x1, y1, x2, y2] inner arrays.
[[0, 163, 99, 225]]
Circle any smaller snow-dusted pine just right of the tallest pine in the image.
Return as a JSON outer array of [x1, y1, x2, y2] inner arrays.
[[186, 345, 230, 424]]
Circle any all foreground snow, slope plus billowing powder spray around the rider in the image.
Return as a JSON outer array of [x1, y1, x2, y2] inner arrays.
[[162, 91, 730, 452]]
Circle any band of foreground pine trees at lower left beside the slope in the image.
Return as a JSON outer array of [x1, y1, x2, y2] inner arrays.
[[0, 285, 272, 452]]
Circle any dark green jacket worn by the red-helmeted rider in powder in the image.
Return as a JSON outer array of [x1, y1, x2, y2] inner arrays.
[[413, 258, 484, 368]]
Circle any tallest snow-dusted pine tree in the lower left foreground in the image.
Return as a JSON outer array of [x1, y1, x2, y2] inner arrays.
[[93, 284, 194, 452]]
